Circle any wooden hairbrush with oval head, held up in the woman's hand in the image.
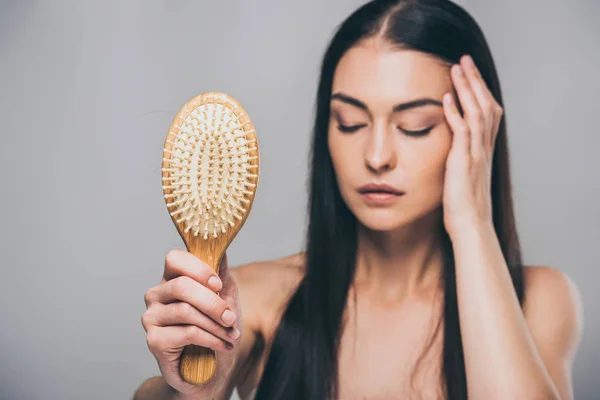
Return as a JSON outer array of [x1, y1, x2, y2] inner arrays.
[[162, 92, 259, 384]]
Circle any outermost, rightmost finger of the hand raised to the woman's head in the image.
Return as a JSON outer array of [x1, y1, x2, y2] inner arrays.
[[461, 56, 498, 151]]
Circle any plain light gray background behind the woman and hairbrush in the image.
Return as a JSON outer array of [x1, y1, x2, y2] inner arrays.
[[0, 0, 600, 400]]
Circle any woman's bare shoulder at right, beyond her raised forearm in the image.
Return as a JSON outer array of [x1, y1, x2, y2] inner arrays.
[[523, 266, 583, 359]]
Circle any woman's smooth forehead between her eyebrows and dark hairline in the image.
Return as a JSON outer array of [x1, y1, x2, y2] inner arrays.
[[332, 40, 452, 109]]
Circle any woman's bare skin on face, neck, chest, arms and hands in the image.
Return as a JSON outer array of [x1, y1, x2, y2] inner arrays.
[[135, 39, 582, 399]]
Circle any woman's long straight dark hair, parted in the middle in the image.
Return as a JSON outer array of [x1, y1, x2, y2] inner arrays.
[[256, 0, 523, 400]]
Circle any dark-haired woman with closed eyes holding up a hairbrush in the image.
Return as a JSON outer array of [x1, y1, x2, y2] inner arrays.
[[136, 0, 581, 400]]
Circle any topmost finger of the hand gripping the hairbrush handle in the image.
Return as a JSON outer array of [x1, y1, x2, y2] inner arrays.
[[163, 250, 223, 292]]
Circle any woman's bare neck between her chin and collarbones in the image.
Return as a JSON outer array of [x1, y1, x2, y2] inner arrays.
[[353, 212, 443, 303]]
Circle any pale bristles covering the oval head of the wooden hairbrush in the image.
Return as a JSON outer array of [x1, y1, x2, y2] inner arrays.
[[163, 96, 258, 239]]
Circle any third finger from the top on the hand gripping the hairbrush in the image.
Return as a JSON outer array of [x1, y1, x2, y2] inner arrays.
[[143, 301, 240, 343]]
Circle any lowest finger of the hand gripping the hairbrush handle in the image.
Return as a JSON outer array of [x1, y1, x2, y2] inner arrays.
[[146, 325, 233, 357]]
